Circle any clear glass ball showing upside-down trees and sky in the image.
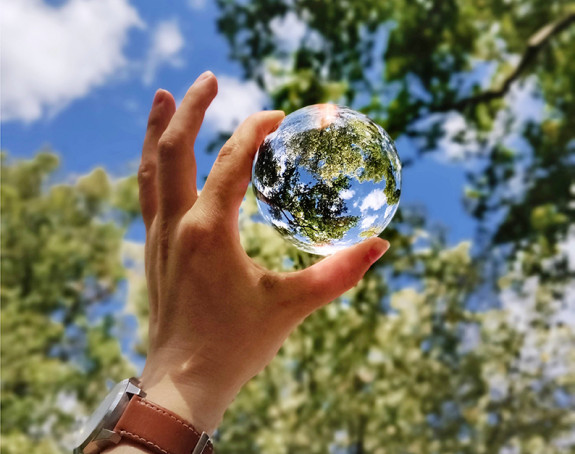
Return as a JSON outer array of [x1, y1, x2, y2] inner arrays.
[[252, 104, 401, 255]]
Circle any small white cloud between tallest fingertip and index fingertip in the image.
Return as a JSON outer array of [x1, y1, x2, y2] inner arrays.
[[206, 76, 267, 132]]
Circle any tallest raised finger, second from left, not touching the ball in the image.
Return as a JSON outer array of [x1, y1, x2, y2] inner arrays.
[[158, 71, 218, 218]]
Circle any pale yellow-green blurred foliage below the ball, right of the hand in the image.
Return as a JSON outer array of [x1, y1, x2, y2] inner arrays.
[[218, 192, 575, 454]]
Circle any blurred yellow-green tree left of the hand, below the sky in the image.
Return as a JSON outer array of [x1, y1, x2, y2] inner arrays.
[[1, 152, 137, 454]]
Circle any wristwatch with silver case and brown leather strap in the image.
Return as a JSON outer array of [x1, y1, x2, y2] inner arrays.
[[74, 377, 214, 454]]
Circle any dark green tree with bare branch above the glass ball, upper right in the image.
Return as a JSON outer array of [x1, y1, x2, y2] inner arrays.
[[218, 0, 575, 250]]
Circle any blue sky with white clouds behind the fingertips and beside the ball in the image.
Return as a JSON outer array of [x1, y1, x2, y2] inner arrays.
[[1, 0, 474, 243]]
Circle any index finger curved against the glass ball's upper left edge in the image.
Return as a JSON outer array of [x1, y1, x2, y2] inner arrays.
[[198, 110, 285, 229]]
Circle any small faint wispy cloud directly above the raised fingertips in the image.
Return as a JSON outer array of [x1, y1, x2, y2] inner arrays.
[[143, 20, 184, 85]]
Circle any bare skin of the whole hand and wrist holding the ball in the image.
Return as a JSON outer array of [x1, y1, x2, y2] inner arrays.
[[107, 72, 389, 454]]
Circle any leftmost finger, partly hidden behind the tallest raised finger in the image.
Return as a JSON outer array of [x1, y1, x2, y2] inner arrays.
[[138, 90, 176, 228]]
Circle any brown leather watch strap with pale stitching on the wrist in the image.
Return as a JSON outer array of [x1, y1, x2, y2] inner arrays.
[[114, 396, 214, 454]]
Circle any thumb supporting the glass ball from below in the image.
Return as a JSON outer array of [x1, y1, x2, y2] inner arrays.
[[283, 238, 389, 317]]
